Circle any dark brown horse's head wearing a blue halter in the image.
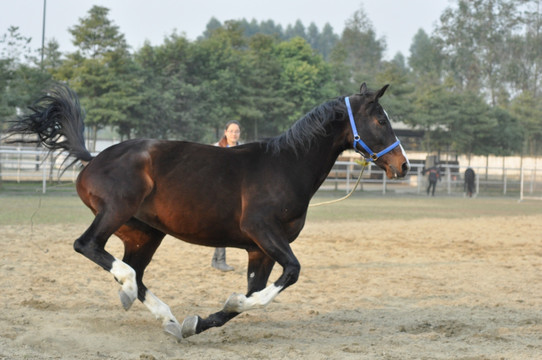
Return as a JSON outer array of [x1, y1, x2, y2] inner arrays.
[[345, 83, 410, 179]]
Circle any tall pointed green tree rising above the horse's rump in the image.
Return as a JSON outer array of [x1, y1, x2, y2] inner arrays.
[[56, 6, 140, 150]]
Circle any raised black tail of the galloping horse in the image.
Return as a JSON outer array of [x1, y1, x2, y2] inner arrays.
[[7, 84, 92, 162]]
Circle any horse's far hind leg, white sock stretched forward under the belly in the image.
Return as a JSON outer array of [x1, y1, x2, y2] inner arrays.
[[115, 218, 182, 339]]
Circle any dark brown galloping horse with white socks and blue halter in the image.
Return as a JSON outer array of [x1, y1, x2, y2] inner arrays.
[[10, 84, 410, 339]]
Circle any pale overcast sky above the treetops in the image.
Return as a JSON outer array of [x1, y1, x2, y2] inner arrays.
[[0, 0, 454, 59]]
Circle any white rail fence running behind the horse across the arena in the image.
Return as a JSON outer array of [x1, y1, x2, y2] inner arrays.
[[0, 147, 542, 198]]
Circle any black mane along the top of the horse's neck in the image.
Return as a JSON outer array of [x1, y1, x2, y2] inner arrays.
[[266, 96, 346, 156]]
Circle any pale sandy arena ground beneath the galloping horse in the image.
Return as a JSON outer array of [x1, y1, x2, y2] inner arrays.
[[0, 216, 542, 360]]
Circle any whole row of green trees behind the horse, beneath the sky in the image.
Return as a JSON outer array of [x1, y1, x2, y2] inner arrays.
[[0, 0, 542, 155]]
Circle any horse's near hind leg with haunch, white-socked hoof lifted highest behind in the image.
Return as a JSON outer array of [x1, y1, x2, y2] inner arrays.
[[74, 151, 153, 310]]
